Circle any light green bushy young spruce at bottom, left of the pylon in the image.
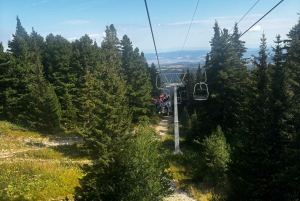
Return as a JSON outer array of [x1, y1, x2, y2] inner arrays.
[[111, 128, 169, 201]]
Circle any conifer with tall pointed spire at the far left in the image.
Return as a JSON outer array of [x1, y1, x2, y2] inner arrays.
[[5, 17, 34, 121]]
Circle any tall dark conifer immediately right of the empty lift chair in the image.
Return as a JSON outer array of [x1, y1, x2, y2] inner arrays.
[[197, 22, 247, 144]]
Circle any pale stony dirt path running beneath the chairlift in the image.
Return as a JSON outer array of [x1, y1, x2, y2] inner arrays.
[[155, 116, 195, 201]]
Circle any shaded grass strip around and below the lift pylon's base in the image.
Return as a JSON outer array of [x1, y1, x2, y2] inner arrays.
[[162, 124, 221, 201]]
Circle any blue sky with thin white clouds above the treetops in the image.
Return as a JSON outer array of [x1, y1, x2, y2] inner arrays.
[[0, 0, 300, 53]]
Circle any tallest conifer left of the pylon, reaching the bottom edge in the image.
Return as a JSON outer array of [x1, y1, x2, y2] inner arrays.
[[75, 25, 131, 200]]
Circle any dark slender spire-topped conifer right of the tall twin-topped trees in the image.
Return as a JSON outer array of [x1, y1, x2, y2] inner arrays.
[[229, 34, 285, 200]]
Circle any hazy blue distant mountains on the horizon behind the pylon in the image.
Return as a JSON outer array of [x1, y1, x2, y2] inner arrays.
[[145, 48, 272, 68]]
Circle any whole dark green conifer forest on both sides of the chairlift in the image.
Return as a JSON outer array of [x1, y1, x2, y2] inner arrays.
[[0, 14, 300, 201]]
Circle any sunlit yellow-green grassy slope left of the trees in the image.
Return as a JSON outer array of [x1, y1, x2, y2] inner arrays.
[[0, 121, 87, 200]]
